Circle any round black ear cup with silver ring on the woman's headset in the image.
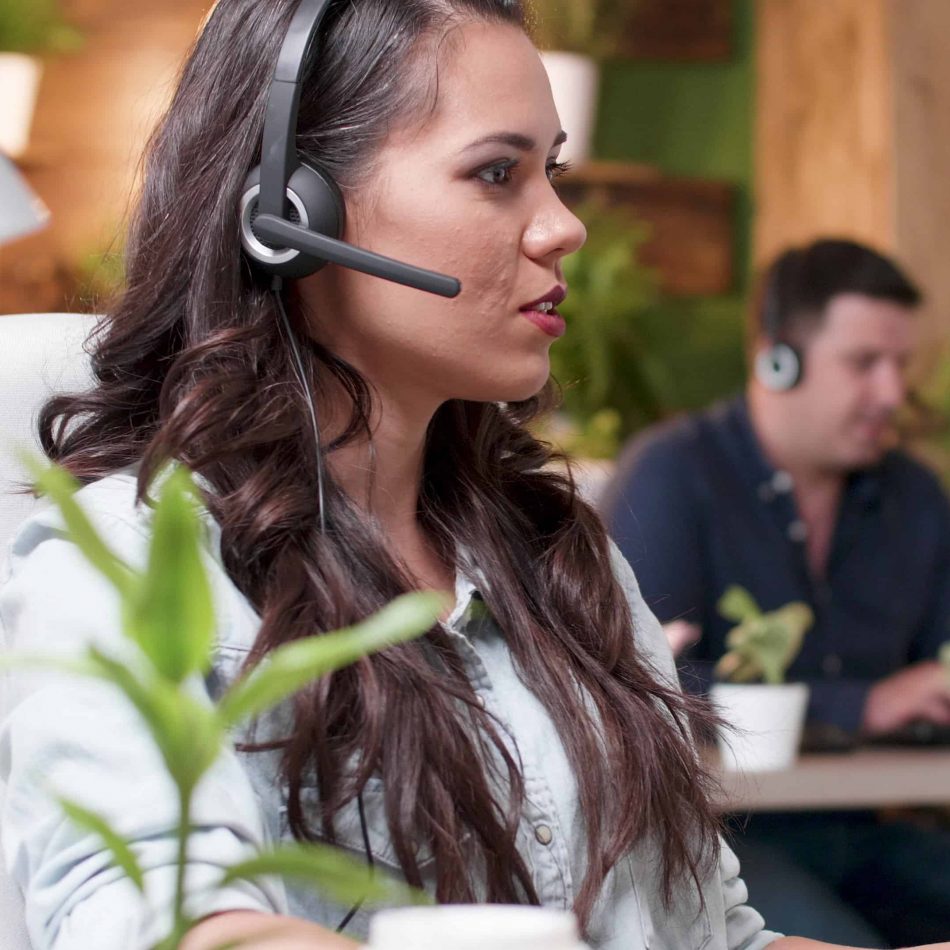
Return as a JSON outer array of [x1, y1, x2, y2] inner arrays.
[[240, 163, 346, 277]]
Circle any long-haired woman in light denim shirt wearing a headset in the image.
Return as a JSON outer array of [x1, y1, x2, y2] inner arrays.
[[0, 0, 944, 950]]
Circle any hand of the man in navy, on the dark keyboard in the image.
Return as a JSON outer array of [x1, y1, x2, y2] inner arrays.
[[861, 660, 950, 735]]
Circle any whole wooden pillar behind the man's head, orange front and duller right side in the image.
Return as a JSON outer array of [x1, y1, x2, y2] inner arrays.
[[754, 0, 950, 342]]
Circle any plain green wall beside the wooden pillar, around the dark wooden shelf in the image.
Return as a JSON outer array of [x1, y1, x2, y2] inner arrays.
[[594, 0, 754, 424]]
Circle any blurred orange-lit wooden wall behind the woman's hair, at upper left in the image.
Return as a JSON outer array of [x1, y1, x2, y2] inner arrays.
[[0, 0, 208, 313]]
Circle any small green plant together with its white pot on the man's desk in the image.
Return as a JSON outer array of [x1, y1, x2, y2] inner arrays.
[[711, 586, 814, 772]]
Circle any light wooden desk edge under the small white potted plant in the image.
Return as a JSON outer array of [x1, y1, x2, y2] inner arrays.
[[709, 748, 950, 811]]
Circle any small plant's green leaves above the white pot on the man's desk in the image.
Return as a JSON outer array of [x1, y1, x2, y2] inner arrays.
[[714, 584, 815, 684]]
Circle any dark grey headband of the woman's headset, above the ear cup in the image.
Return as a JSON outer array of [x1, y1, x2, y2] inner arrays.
[[258, 0, 331, 218]]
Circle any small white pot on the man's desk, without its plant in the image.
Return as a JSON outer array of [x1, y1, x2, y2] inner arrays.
[[711, 683, 808, 772]]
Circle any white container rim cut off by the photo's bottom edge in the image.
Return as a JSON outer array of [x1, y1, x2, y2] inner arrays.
[[367, 904, 585, 950]]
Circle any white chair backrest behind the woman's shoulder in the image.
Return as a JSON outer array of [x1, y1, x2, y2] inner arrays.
[[0, 313, 96, 950]]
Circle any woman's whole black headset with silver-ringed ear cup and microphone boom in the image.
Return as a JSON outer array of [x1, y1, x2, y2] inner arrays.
[[240, 0, 461, 297]]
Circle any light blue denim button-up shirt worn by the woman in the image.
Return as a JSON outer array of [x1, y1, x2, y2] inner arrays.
[[0, 473, 778, 950]]
